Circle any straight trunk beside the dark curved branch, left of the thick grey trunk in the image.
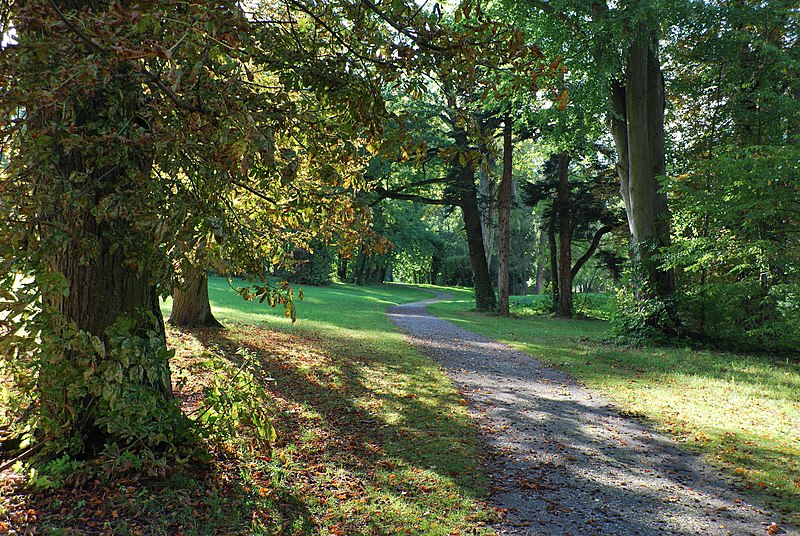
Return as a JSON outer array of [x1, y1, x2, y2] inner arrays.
[[553, 152, 572, 318]]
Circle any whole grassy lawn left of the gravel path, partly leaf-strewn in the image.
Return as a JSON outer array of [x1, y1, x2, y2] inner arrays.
[[0, 278, 498, 535]]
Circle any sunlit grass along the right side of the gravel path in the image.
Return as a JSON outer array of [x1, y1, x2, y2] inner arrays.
[[429, 289, 800, 524]]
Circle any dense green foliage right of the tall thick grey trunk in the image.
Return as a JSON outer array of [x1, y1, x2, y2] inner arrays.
[[665, 2, 800, 350]]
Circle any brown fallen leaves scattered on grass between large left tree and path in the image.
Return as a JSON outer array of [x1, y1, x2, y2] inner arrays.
[[0, 326, 498, 535]]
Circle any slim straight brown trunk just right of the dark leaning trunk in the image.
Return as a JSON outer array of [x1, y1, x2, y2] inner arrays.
[[497, 114, 514, 317]]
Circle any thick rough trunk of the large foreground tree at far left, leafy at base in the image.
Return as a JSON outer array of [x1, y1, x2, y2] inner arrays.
[[18, 1, 177, 456]]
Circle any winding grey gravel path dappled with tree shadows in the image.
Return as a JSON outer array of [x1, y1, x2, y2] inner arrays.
[[388, 293, 800, 536]]
